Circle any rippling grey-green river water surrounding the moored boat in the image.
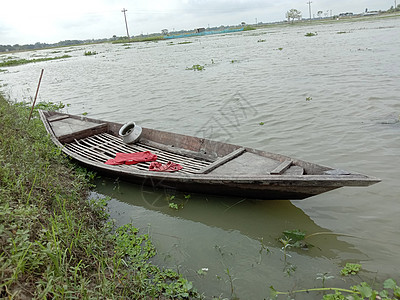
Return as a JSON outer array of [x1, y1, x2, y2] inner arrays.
[[0, 18, 400, 299]]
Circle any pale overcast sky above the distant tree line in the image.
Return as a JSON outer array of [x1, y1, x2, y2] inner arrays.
[[0, 0, 394, 45]]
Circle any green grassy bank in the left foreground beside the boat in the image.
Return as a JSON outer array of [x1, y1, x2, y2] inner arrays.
[[0, 95, 199, 299]]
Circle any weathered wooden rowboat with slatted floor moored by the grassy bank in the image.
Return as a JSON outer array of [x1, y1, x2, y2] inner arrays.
[[39, 111, 380, 200]]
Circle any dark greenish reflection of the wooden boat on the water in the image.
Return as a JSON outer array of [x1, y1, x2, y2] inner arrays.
[[96, 178, 363, 259]]
